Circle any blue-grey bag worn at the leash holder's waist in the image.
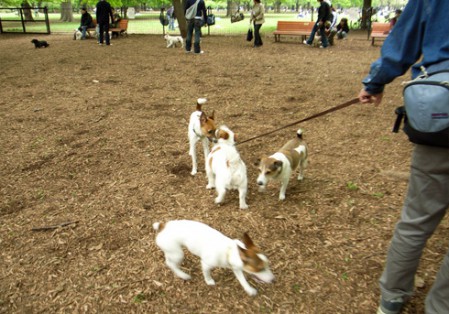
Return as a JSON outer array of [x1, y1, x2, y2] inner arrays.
[[396, 68, 449, 147]]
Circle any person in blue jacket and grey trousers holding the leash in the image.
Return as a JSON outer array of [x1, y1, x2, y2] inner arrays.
[[359, 0, 449, 314]]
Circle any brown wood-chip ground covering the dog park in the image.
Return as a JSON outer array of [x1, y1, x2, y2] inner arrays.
[[0, 29, 449, 313]]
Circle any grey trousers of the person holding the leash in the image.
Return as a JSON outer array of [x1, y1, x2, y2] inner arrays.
[[379, 145, 449, 314]]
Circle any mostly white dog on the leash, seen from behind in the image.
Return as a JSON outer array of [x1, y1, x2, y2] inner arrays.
[[206, 126, 248, 209]]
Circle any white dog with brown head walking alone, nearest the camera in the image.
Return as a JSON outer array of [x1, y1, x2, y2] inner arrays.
[[153, 220, 274, 296]]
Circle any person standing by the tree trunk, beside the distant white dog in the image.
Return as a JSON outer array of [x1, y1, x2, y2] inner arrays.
[[184, 0, 207, 54]]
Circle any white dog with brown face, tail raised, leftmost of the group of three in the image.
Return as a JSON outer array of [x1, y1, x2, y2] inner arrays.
[[188, 98, 216, 176]]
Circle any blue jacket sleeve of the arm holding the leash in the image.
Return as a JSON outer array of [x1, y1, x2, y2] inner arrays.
[[362, 0, 425, 94]]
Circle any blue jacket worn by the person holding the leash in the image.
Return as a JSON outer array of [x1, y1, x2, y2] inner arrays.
[[362, 0, 449, 95]]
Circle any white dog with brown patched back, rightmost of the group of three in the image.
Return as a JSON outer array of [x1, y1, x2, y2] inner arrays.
[[256, 129, 307, 200]]
